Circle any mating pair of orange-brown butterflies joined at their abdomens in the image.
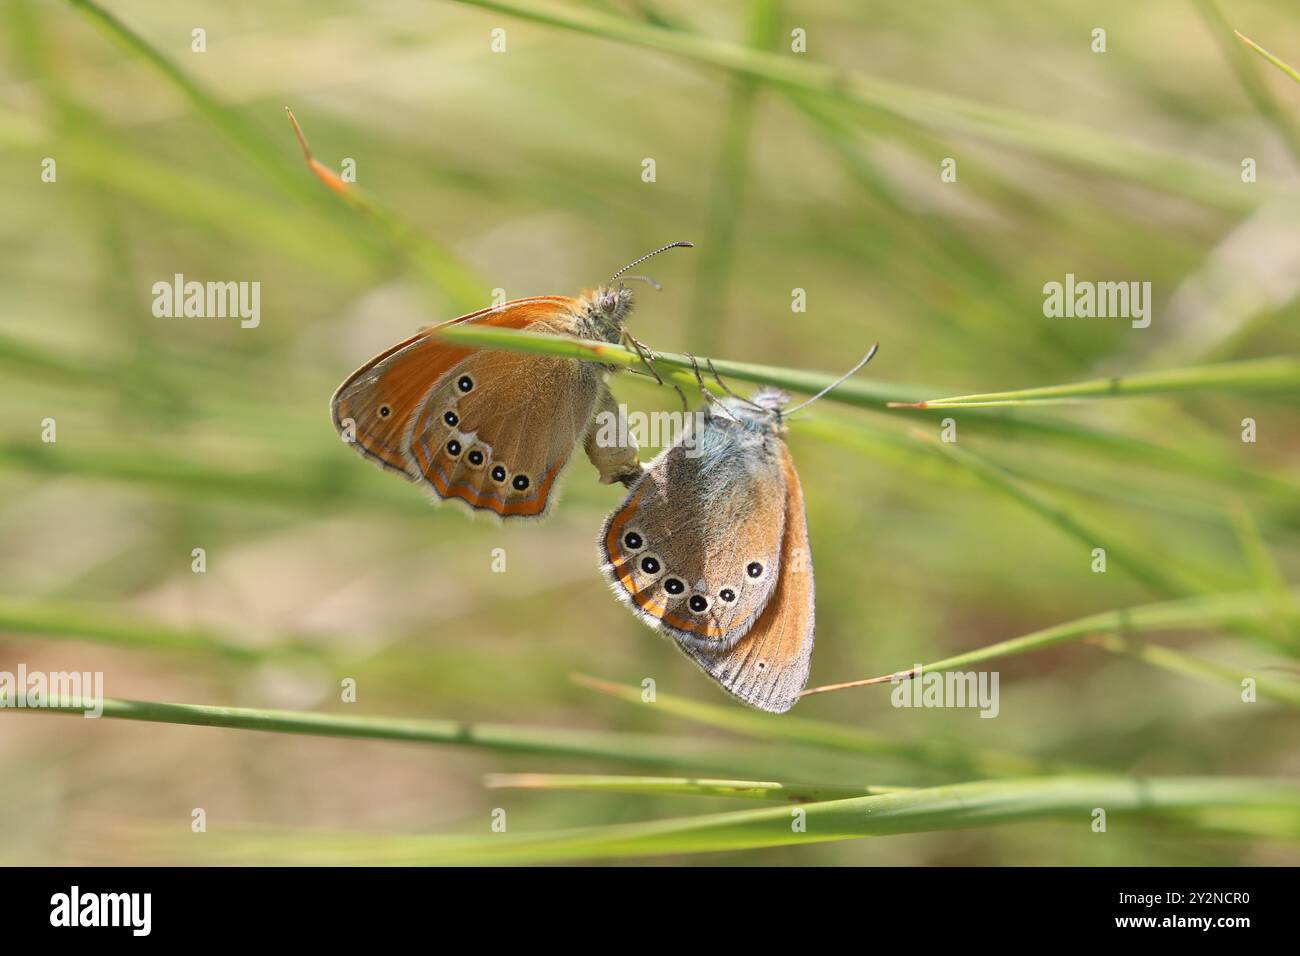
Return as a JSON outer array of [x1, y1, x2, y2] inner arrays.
[[330, 242, 861, 713]]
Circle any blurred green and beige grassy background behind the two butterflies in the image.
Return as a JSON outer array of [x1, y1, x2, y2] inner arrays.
[[0, 0, 1300, 865]]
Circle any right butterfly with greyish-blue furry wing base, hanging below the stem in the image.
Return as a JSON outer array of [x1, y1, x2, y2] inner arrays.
[[598, 347, 876, 713]]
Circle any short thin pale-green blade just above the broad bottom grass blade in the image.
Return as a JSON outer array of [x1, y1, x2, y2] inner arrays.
[[484, 774, 898, 804]]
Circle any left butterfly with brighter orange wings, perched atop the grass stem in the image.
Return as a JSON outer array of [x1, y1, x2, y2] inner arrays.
[[330, 242, 692, 519]]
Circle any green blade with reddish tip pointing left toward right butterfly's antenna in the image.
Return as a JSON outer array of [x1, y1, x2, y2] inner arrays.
[[896, 356, 1300, 408]]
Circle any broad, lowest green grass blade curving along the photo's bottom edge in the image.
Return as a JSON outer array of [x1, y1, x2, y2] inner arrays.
[[156, 777, 1300, 865]]
